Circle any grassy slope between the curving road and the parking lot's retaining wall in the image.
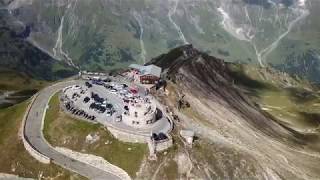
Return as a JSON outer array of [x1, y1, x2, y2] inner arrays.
[[44, 94, 147, 177]]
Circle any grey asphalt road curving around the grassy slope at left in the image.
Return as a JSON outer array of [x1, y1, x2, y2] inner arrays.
[[24, 81, 120, 180]]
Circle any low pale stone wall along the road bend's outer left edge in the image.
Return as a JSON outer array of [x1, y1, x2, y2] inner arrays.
[[20, 94, 50, 164]]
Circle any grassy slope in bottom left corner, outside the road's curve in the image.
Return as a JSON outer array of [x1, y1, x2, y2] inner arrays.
[[0, 102, 82, 179]]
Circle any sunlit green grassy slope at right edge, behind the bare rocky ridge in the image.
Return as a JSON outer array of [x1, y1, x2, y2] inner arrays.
[[229, 63, 320, 131]]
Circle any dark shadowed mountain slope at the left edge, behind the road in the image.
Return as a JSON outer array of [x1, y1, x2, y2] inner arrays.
[[0, 9, 76, 80]]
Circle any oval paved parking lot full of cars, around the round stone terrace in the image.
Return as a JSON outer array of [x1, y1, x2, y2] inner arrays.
[[62, 79, 171, 135]]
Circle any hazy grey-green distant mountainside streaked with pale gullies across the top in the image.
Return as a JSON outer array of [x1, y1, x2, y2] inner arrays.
[[2, 0, 320, 82]]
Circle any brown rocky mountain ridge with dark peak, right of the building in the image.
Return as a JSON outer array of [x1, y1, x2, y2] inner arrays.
[[152, 46, 320, 179]]
